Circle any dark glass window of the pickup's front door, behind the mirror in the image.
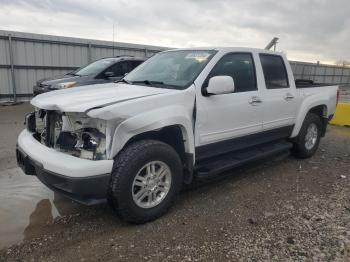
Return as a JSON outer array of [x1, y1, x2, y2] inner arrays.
[[205, 53, 257, 93]]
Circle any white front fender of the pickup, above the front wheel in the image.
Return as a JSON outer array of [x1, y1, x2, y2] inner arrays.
[[87, 85, 195, 159]]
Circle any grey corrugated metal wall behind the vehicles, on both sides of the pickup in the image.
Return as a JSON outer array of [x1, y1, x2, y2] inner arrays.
[[0, 30, 350, 101]]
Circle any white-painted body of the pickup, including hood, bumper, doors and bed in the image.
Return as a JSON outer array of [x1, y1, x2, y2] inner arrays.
[[18, 48, 338, 176]]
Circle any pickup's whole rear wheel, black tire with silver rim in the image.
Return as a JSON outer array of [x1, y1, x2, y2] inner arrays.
[[293, 113, 321, 158]]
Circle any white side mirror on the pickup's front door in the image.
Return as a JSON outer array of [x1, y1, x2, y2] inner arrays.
[[204, 76, 235, 96]]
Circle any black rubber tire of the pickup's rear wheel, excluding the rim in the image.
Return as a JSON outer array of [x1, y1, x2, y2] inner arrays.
[[292, 113, 322, 158]]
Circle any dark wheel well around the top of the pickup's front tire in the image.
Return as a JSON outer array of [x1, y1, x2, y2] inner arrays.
[[125, 125, 193, 183]]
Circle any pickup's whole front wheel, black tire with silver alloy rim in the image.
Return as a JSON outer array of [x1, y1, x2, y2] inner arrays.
[[108, 140, 182, 224]]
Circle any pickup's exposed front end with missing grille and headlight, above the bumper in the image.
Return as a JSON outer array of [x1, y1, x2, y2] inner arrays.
[[26, 108, 107, 160]]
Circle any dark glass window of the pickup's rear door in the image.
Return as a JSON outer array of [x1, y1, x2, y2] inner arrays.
[[260, 54, 289, 89]]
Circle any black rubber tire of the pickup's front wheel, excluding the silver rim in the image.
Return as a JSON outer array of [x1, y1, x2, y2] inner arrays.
[[108, 140, 182, 224]]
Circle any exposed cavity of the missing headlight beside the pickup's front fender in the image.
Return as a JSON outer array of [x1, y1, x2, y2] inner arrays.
[[55, 113, 106, 160]]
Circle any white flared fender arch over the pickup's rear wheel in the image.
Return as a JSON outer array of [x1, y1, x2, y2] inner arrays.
[[290, 93, 329, 138]]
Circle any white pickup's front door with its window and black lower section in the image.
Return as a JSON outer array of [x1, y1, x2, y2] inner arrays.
[[195, 53, 262, 158]]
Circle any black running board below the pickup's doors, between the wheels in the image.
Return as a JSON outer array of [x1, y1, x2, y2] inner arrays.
[[194, 141, 292, 179]]
